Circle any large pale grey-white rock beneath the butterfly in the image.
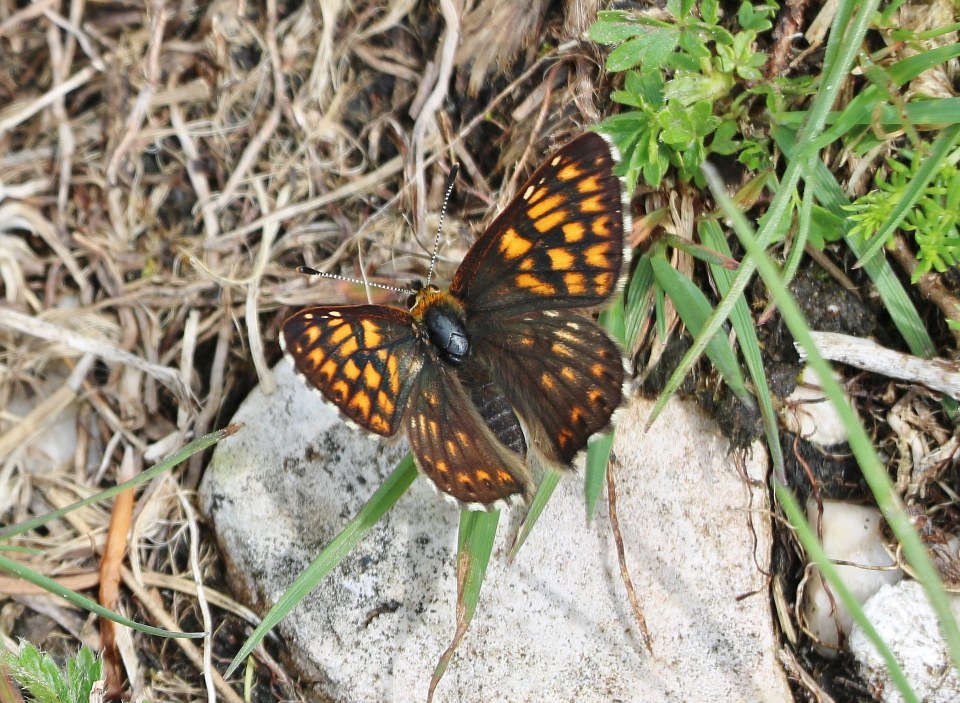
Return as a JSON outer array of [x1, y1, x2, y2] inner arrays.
[[201, 362, 792, 703]]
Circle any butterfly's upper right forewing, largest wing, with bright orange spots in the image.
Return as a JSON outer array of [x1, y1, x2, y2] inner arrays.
[[450, 133, 630, 315]]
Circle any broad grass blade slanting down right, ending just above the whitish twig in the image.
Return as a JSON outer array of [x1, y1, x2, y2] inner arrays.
[[772, 128, 936, 358]]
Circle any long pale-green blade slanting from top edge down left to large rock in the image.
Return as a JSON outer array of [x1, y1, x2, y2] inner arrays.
[[647, 0, 880, 427]]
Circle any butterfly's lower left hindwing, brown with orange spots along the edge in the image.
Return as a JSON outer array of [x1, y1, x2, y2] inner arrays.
[[407, 357, 531, 509]]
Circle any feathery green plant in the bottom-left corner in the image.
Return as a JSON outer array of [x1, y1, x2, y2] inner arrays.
[[3, 642, 103, 703]]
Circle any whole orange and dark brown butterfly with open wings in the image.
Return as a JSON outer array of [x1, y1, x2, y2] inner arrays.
[[281, 133, 630, 509]]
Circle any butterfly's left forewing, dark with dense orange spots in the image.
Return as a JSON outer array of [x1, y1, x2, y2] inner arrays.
[[280, 305, 425, 436]]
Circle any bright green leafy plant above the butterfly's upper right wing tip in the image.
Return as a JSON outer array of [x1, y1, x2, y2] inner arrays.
[[590, 0, 775, 188]]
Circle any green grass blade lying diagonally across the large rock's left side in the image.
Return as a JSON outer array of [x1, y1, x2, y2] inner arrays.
[[224, 454, 417, 677]]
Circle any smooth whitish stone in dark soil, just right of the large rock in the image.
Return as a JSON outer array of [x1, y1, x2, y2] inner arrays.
[[803, 500, 903, 656]]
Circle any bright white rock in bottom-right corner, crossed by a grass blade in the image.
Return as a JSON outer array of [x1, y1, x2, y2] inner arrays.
[[850, 580, 960, 703]]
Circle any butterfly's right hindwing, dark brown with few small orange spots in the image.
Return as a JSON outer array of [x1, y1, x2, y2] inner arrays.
[[467, 310, 624, 466]]
